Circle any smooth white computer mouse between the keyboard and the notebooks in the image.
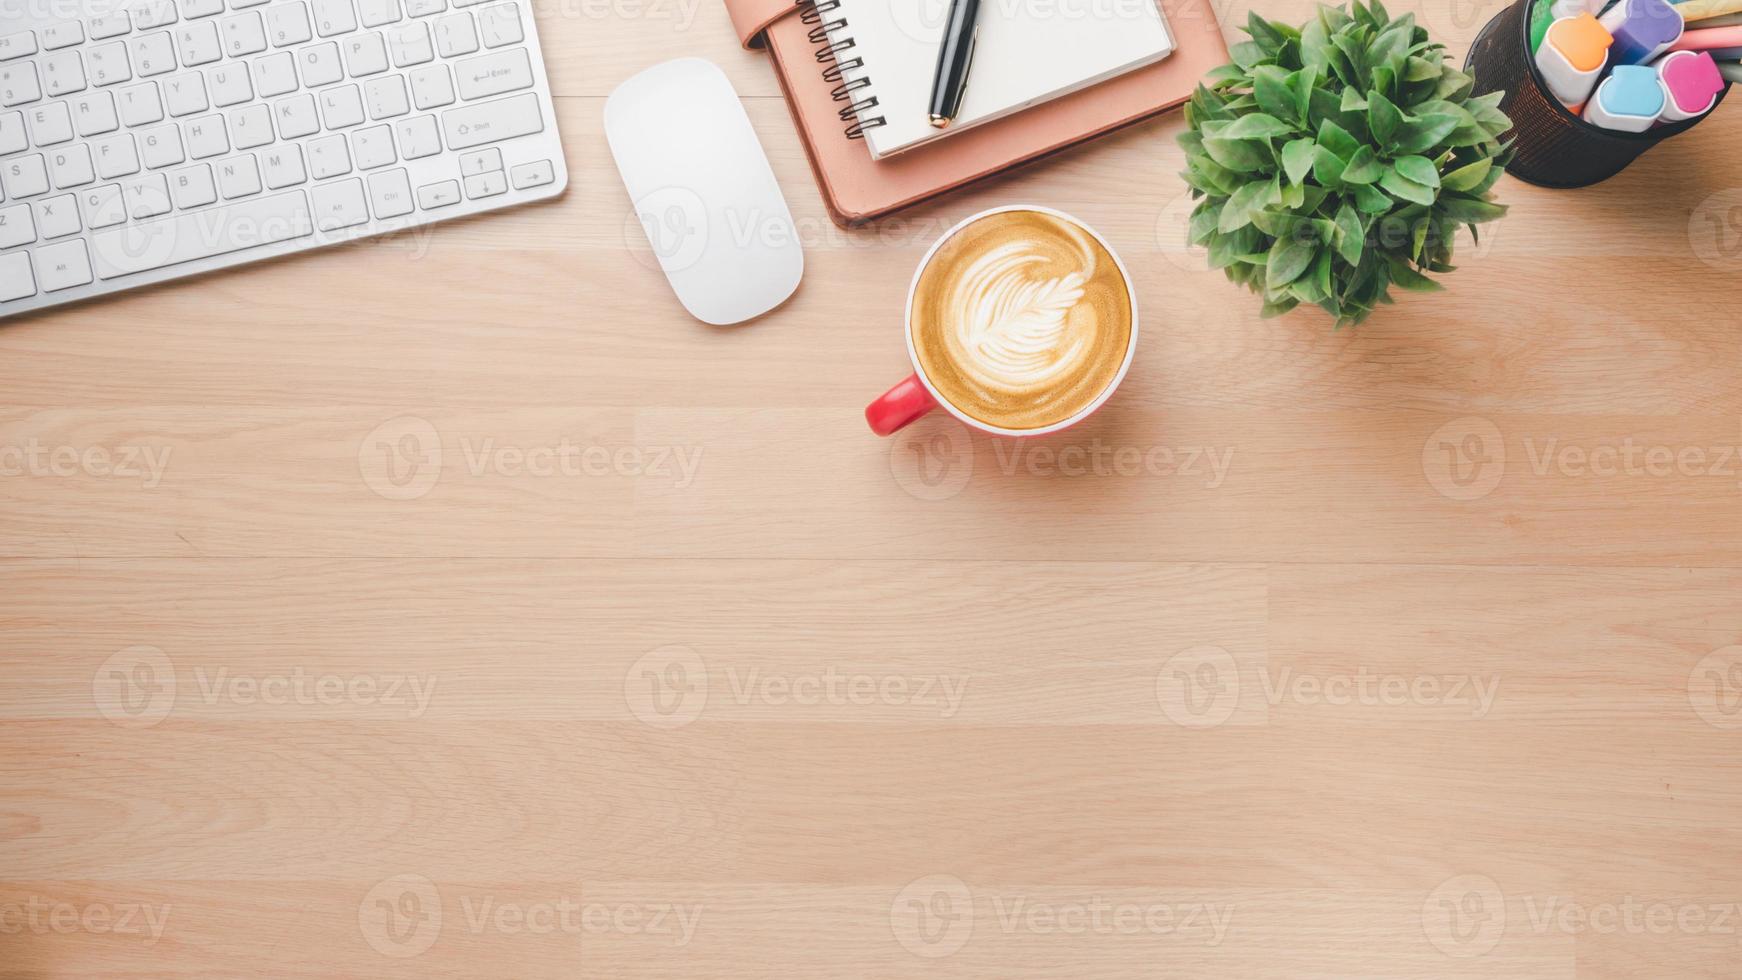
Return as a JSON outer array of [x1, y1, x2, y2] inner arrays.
[[604, 57, 805, 324]]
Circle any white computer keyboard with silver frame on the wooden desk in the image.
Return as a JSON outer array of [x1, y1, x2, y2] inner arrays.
[[0, 0, 568, 317]]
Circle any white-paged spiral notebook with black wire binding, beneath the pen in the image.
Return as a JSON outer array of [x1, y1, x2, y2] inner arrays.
[[815, 0, 1174, 158]]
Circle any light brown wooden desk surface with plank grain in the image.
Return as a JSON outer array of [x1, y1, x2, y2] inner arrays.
[[0, 0, 1742, 978]]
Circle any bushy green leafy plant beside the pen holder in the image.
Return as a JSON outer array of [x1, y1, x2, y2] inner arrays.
[[1179, 0, 1512, 327]]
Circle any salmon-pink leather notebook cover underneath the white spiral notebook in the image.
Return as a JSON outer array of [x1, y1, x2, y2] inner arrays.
[[726, 0, 1228, 226]]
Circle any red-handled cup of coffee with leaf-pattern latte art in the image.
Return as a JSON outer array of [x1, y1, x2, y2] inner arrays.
[[866, 205, 1138, 435]]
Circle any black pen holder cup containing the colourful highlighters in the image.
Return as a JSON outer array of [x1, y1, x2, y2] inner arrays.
[[1463, 0, 1730, 188]]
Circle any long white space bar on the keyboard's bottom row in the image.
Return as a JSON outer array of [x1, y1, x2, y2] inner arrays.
[[91, 190, 314, 279]]
